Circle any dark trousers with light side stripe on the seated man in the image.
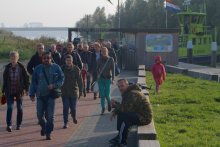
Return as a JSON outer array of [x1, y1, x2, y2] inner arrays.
[[117, 112, 140, 144]]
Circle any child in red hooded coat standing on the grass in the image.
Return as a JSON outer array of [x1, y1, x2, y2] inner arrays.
[[151, 56, 166, 93]]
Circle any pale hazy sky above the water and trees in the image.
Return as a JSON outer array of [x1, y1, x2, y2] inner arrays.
[[0, 0, 118, 27]]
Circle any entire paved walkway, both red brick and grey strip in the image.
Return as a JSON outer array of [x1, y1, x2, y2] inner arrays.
[[0, 71, 137, 147]]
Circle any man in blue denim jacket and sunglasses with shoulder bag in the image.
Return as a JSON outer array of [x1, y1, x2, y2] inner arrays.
[[29, 52, 64, 140]]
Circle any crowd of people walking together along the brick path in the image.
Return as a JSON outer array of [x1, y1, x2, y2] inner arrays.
[[2, 42, 117, 140]]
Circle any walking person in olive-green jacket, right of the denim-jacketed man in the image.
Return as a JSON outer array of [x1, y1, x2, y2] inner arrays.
[[61, 55, 83, 129]]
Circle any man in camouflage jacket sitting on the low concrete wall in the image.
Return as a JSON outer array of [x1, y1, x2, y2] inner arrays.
[[109, 79, 152, 146]]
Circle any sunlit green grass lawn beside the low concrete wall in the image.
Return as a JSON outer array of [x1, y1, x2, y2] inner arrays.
[[147, 72, 220, 147]]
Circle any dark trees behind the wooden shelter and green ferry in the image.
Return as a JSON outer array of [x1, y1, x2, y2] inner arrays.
[[76, 0, 220, 42]]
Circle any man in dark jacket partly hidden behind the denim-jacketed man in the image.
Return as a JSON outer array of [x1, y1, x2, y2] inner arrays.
[[27, 43, 44, 75]]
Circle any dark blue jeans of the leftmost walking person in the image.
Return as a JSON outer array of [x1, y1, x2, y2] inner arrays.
[[6, 95, 23, 126]]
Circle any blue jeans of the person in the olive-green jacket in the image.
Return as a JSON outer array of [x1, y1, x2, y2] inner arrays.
[[62, 96, 77, 124]]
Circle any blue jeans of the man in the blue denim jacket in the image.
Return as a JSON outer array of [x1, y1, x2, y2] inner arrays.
[[37, 96, 55, 135]]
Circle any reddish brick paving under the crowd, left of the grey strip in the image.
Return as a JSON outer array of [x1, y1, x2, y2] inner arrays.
[[0, 94, 99, 147]]
